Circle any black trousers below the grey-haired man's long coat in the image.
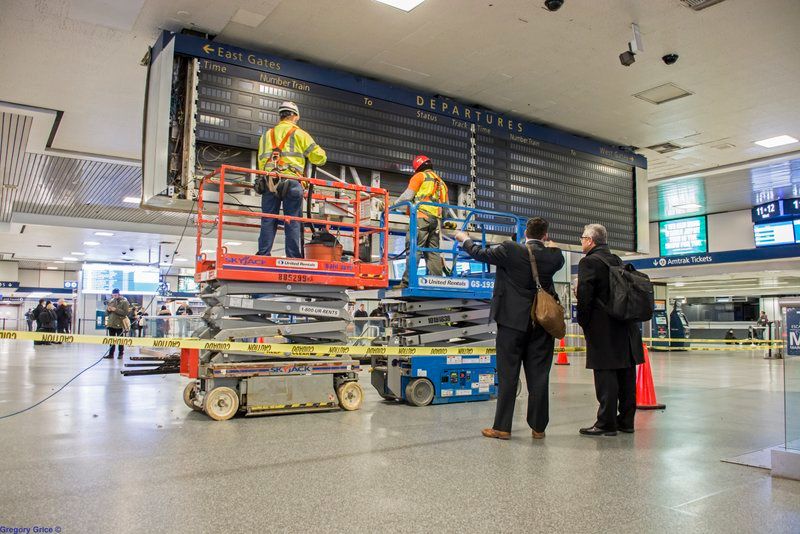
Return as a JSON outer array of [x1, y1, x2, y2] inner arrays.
[[594, 367, 636, 430]]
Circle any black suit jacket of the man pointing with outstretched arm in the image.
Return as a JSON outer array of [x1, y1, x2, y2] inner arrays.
[[461, 239, 564, 332]]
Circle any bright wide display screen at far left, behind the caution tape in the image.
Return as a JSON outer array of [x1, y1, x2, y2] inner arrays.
[[81, 263, 159, 296]]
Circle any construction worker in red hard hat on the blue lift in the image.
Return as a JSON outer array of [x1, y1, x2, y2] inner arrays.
[[397, 155, 447, 287]]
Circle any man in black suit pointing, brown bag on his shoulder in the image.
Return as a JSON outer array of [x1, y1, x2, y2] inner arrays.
[[455, 217, 564, 439]]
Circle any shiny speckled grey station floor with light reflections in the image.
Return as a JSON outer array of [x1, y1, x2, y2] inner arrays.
[[0, 341, 800, 533]]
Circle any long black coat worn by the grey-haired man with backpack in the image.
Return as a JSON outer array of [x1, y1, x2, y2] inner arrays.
[[578, 245, 644, 369]]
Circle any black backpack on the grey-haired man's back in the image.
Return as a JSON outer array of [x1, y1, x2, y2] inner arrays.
[[598, 255, 655, 322]]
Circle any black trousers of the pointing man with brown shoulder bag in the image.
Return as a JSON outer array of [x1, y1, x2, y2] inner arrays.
[[492, 325, 553, 432]]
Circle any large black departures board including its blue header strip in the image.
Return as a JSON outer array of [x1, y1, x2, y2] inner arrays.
[[153, 32, 648, 251]]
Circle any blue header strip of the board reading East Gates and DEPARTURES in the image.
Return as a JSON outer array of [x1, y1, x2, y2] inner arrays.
[[152, 31, 647, 168]]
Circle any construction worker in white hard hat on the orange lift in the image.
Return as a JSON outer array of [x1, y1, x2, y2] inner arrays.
[[255, 102, 328, 258]]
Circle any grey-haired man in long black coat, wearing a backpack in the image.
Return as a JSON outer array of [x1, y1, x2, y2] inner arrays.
[[578, 224, 644, 436]]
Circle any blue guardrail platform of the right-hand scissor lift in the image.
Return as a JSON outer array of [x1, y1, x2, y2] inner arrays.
[[381, 201, 527, 292]]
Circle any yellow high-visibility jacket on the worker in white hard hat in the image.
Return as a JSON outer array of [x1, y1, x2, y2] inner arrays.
[[258, 120, 328, 176]]
